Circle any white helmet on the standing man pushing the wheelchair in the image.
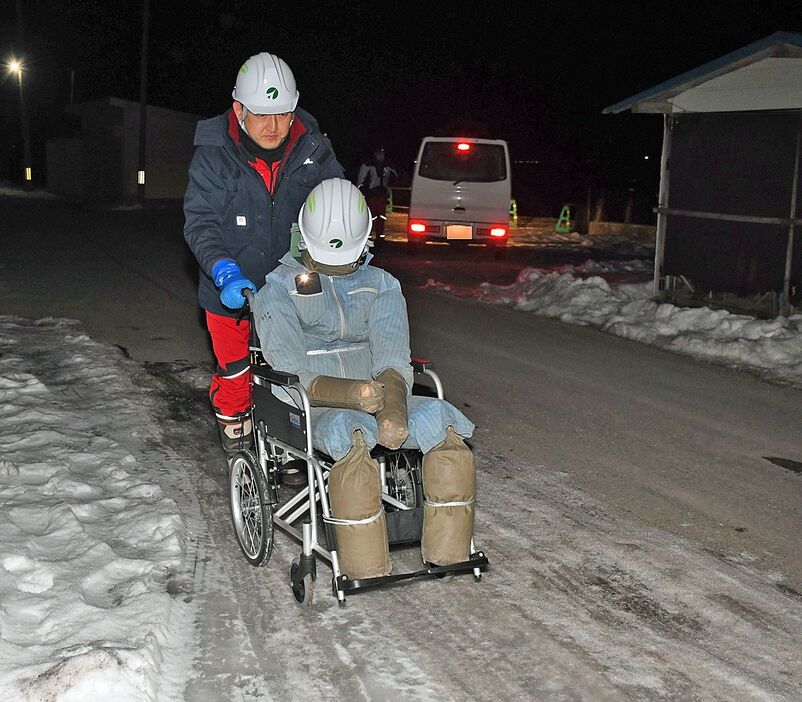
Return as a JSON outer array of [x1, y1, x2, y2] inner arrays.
[[231, 53, 298, 115]]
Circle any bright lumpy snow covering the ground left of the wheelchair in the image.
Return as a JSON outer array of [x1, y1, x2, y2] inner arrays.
[[0, 316, 190, 700]]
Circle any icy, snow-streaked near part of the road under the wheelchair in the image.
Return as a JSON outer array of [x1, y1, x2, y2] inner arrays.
[[143, 364, 802, 700]]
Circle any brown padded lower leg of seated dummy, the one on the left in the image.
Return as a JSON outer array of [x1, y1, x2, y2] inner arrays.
[[329, 431, 391, 579]]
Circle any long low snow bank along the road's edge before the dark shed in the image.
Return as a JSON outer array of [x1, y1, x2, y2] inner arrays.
[[473, 261, 802, 387]]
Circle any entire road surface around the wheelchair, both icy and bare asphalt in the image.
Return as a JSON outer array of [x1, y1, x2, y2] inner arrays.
[[0, 195, 802, 701]]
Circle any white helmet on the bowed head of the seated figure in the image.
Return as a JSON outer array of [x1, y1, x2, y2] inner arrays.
[[298, 178, 372, 266]]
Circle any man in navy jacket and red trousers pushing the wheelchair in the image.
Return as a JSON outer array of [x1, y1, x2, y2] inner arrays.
[[184, 53, 343, 456]]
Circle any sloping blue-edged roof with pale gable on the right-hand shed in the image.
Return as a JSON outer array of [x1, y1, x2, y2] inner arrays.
[[602, 32, 802, 114]]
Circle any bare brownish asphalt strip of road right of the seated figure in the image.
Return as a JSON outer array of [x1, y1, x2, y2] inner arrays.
[[398, 290, 802, 591]]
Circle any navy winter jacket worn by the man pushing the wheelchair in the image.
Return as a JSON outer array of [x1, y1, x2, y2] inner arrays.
[[184, 109, 343, 317]]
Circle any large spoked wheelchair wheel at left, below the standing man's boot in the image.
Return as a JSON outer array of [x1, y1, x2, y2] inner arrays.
[[228, 451, 274, 566]]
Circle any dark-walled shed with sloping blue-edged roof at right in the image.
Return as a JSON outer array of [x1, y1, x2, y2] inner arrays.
[[604, 32, 802, 314]]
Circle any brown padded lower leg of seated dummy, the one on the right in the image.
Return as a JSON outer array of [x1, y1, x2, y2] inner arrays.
[[421, 427, 476, 565]]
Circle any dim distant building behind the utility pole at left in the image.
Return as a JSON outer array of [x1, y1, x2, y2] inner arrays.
[[47, 97, 200, 202]]
